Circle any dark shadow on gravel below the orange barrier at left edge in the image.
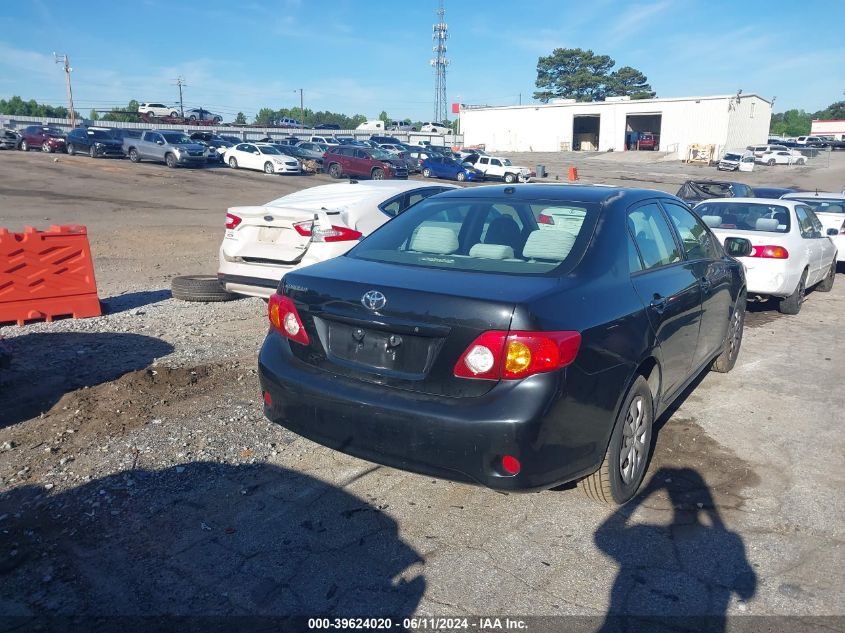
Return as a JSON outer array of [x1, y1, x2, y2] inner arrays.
[[0, 332, 173, 428]]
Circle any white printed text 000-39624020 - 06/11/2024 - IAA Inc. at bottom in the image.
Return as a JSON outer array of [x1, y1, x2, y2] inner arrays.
[[308, 617, 528, 632]]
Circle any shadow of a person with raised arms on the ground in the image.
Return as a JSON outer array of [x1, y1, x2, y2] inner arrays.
[[594, 467, 757, 633]]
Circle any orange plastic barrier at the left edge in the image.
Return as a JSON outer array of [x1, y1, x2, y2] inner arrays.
[[0, 225, 102, 325]]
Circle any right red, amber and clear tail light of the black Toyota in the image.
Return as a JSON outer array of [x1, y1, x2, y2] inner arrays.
[[455, 330, 581, 380]]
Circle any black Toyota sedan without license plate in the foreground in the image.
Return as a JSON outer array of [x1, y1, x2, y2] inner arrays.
[[259, 184, 751, 503]]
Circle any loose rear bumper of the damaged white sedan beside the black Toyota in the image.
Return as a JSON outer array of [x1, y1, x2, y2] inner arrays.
[[217, 240, 358, 298]]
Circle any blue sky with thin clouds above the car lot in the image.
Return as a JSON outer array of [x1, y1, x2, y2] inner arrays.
[[0, 0, 845, 120]]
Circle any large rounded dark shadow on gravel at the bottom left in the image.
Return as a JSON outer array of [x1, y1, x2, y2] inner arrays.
[[0, 462, 425, 632]]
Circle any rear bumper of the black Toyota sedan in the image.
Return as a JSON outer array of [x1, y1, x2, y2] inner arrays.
[[254, 331, 614, 491]]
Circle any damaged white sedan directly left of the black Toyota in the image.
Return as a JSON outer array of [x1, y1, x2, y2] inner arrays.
[[217, 180, 455, 297]]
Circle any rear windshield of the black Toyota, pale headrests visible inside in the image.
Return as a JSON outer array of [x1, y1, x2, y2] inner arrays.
[[349, 197, 599, 275]]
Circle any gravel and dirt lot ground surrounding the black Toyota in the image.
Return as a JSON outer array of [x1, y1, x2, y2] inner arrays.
[[0, 152, 845, 630]]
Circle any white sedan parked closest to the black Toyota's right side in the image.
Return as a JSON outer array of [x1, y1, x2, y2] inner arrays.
[[695, 198, 836, 314]]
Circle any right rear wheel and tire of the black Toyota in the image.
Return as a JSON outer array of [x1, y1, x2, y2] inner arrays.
[[578, 376, 654, 505]]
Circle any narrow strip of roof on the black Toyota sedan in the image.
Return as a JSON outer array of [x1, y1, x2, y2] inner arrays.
[[443, 183, 680, 204]]
